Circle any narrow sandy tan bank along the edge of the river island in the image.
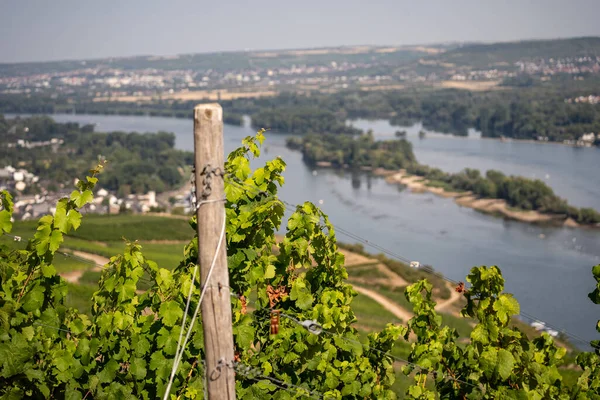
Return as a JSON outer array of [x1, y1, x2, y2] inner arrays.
[[372, 168, 596, 228]]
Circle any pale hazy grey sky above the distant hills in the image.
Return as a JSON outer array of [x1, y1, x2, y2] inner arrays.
[[0, 0, 600, 62]]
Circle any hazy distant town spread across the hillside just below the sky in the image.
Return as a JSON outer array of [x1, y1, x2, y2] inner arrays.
[[0, 47, 600, 100]]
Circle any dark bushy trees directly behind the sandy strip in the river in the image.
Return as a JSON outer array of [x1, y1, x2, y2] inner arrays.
[[407, 164, 600, 224]]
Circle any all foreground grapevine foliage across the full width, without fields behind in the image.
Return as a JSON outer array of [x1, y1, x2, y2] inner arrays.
[[0, 132, 600, 399]]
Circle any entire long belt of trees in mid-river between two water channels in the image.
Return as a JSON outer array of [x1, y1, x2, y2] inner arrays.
[[286, 131, 600, 224]]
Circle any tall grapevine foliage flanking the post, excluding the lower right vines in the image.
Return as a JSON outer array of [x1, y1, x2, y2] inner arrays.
[[0, 133, 404, 398]]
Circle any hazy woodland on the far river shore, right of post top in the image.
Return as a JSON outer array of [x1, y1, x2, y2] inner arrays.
[[243, 82, 600, 145]]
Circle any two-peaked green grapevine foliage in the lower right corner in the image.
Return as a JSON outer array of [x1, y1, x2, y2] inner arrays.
[[398, 266, 600, 399]]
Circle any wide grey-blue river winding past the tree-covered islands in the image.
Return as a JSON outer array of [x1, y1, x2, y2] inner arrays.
[[9, 114, 600, 346]]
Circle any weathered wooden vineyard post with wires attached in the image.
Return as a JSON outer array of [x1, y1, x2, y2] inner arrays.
[[194, 103, 235, 400]]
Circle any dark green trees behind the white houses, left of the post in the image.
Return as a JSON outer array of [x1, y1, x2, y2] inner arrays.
[[0, 117, 193, 195]]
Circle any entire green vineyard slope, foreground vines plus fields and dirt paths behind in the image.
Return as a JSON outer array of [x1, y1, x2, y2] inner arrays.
[[0, 133, 600, 399]]
